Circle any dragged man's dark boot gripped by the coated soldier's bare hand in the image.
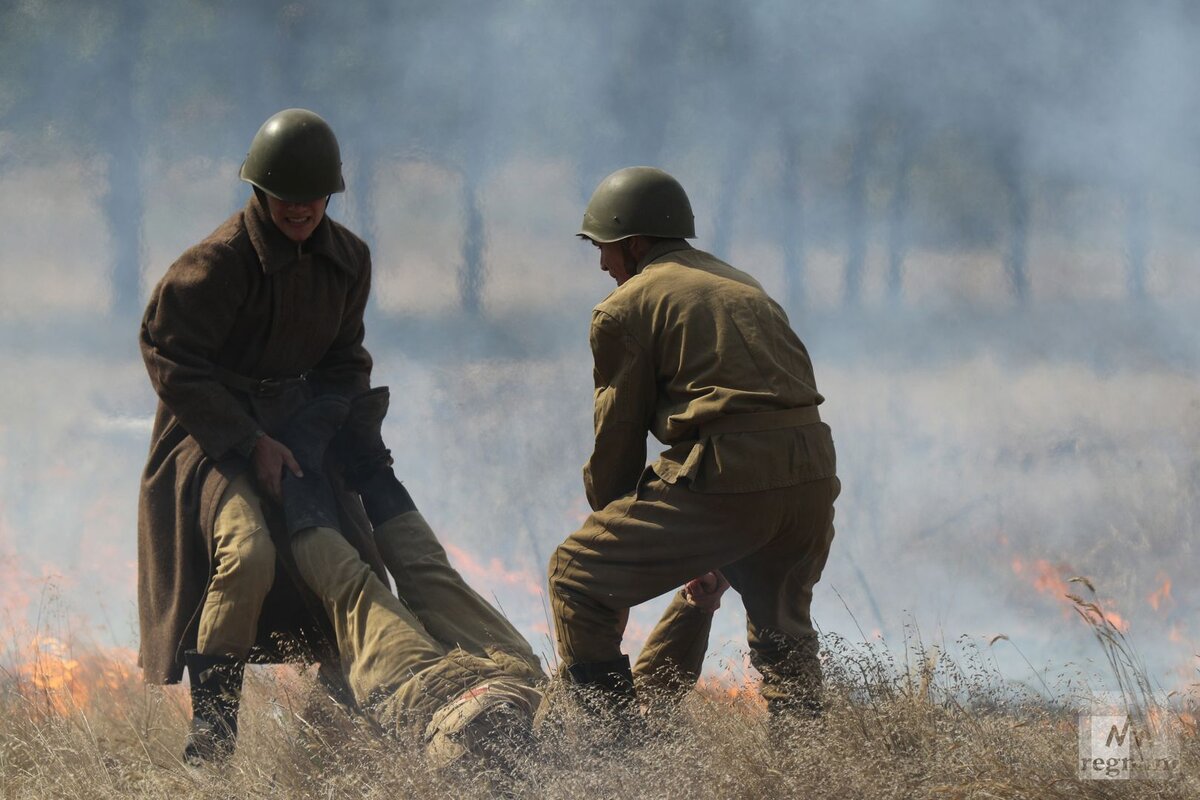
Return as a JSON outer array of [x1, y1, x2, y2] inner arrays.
[[280, 395, 350, 536]]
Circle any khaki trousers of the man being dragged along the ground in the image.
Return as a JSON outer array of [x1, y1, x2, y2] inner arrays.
[[292, 528, 541, 728]]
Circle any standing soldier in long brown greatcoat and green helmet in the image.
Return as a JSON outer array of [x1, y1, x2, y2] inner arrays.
[[138, 109, 403, 762]]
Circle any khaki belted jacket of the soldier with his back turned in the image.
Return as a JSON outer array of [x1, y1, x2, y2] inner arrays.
[[583, 239, 836, 510]]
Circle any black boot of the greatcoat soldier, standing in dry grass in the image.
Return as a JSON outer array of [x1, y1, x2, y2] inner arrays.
[[184, 650, 246, 766]]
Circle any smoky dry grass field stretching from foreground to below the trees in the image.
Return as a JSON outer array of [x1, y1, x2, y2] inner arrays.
[[0, 331, 1200, 800]]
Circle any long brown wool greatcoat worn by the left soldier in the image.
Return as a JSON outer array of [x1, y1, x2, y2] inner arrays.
[[138, 197, 388, 684]]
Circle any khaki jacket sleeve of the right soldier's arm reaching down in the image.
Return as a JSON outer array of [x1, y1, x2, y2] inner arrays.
[[583, 311, 656, 511]]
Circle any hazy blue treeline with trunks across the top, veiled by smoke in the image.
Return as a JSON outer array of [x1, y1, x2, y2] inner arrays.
[[0, 0, 1200, 314]]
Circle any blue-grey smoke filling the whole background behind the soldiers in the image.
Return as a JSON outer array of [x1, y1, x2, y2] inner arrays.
[[0, 0, 1200, 684]]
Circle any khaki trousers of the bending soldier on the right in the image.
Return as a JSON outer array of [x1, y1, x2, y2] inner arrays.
[[550, 470, 840, 702]]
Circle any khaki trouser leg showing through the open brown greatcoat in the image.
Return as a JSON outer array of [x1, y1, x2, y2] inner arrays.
[[196, 474, 275, 658]]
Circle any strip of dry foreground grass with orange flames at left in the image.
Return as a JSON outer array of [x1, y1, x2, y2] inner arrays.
[[0, 592, 1200, 799]]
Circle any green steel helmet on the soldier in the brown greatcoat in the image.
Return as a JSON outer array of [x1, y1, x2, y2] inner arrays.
[[241, 108, 346, 203]]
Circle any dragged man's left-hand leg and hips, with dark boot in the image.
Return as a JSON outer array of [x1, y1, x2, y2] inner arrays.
[[282, 397, 540, 766]]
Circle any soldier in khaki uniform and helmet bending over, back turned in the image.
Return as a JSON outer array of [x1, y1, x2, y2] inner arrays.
[[550, 167, 840, 714]]
